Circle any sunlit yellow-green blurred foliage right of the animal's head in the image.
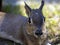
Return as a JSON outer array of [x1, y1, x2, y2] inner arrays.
[[43, 4, 60, 38]]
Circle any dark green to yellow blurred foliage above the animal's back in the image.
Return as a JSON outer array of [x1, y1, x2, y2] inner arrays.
[[2, 4, 26, 16]]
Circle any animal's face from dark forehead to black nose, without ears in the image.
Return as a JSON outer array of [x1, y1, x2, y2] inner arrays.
[[26, 9, 45, 36]]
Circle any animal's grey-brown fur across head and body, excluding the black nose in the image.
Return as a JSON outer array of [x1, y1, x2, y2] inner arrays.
[[0, 0, 47, 45]]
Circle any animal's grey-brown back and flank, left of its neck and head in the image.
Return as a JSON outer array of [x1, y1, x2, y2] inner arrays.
[[0, 12, 27, 43]]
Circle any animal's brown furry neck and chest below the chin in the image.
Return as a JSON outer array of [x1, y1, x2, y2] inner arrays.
[[24, 32, 47, 45]]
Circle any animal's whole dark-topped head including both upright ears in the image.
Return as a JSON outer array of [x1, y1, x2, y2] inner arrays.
[[25, 1, 45, 37]]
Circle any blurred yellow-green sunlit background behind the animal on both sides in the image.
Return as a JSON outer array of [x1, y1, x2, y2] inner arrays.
[[2, 0, 60, 44]]
